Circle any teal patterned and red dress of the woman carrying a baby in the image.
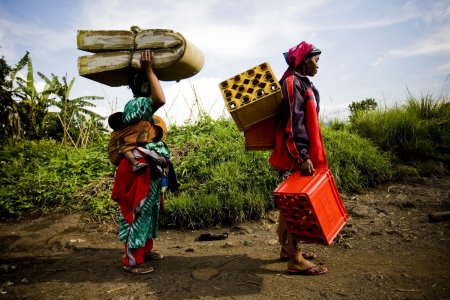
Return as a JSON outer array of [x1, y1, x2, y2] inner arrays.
[[112, 97, 170, 266]]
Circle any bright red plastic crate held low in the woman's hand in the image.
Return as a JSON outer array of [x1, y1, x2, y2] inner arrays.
[[273, 170, 348, 245]]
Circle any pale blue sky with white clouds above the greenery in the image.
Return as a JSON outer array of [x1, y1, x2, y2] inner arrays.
[[0, 0, 450, 125]]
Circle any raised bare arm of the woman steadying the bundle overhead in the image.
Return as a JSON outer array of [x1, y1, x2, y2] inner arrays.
[[140, 50, 166, 110]]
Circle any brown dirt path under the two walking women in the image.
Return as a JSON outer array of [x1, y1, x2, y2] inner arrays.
[[0, 177, 450, 299]]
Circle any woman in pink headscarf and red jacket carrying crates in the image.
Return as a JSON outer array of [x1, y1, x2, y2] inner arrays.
[[269, 41, 328, 275]]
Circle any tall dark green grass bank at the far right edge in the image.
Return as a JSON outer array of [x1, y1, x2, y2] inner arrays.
[[350, 96, 450, 175]]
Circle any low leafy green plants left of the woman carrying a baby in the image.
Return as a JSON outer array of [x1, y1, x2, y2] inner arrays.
[[0, 140, 112, 216]]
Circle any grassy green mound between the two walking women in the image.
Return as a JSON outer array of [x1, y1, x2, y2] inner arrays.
[[165, 116, 277, 227]]
